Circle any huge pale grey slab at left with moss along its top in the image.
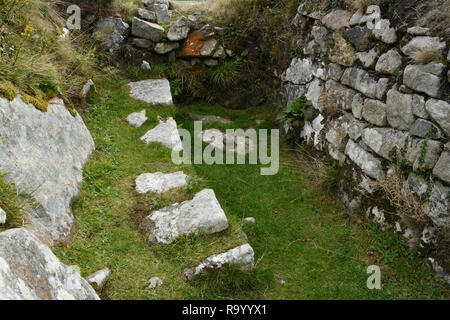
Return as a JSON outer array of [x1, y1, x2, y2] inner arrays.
[[0, 96, 95, 243]]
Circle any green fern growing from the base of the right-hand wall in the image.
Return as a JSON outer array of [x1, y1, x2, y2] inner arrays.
[[277, 95, 314, 140]]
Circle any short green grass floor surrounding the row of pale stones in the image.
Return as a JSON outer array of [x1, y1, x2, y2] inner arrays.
[[55, 70, 448, 299]]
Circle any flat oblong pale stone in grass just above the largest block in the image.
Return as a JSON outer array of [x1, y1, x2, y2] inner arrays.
[[136, 171, 188, 194]]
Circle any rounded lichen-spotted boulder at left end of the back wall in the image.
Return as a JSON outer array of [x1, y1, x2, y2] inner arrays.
[[97, 17, 130, 52]]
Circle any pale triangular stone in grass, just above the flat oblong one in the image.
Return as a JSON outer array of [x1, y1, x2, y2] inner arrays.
[[141, 118, 183, 151]]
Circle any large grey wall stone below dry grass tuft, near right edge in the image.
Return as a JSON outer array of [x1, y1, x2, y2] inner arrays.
[[403, 65, 442, 98]]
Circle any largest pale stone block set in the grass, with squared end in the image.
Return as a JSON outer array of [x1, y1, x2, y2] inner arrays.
[[141, 189, 228, 244]]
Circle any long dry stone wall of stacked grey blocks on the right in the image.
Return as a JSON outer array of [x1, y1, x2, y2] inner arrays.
[[281, 5, 450, 280]]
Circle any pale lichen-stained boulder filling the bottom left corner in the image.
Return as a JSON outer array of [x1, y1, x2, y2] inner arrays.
[[0, 228, 99, 300]]
